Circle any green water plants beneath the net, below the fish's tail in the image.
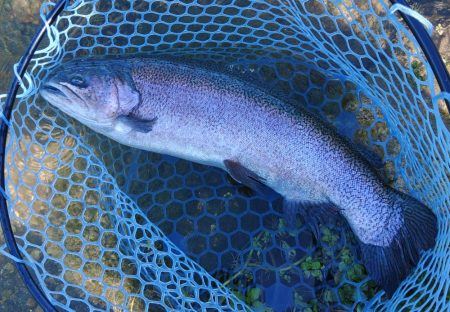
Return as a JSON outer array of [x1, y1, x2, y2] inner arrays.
[[218, 214, 379, 312]]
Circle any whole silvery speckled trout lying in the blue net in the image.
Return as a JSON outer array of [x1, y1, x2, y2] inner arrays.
[[39, 57, 438, 296]]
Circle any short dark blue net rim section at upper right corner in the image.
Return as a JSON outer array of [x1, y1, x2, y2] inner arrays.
[[391, 0, 450, 112]]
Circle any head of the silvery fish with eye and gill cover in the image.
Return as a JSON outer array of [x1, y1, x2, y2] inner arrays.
[[40, 60, 140, 126]]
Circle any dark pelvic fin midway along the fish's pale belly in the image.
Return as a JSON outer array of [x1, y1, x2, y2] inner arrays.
[[223, 159, 280, 197]]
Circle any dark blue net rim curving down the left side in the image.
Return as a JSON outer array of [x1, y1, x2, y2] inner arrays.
[[0, 0, 70, 312]]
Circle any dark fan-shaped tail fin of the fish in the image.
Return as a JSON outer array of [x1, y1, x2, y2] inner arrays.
[[361, 192, 437, 297]]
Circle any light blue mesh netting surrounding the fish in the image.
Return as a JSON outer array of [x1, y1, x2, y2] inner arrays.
[[0, 0, 450, 311]]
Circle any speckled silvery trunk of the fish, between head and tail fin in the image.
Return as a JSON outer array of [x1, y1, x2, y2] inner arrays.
[[127, 60, 402, 246]]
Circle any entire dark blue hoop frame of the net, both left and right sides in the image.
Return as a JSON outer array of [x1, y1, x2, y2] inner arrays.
[[0, 0, 450, 311]]
